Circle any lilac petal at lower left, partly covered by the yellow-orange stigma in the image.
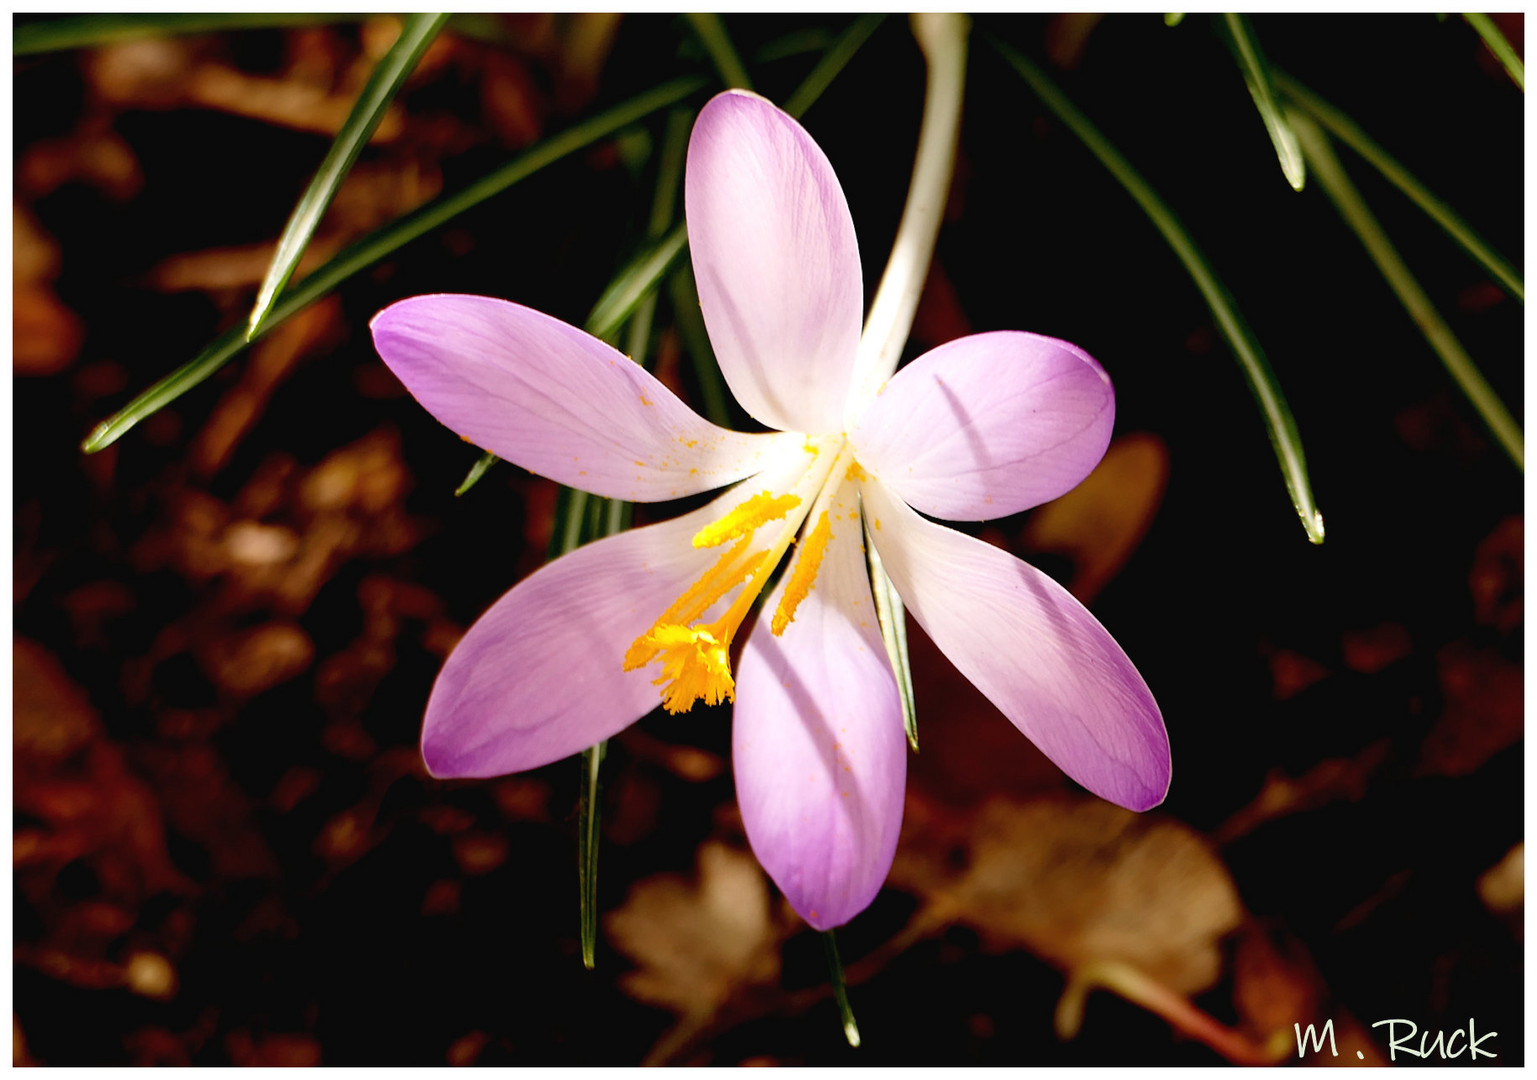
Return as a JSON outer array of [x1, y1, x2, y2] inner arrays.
[[421, 495, 732, 777]]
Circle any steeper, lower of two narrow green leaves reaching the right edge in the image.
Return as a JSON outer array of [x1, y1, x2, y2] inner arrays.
[[1291, 112, 1526, 472]]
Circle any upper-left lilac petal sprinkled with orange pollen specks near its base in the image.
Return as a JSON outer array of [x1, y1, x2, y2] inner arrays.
[[373, 295, 788, 502]]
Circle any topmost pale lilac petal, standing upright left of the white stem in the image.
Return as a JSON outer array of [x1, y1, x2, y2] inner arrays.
[[684, 91, 864, 435]]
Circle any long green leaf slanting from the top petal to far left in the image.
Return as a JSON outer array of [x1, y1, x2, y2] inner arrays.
[[81, 77, 704, 453]]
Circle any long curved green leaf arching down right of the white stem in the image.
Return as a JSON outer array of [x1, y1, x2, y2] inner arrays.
[[988, 38, 1323, 544]]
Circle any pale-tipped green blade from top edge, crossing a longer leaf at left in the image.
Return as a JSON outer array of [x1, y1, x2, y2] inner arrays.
[[246, 14, 449, 341]]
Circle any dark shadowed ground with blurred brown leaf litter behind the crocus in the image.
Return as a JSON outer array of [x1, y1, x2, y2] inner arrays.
[[12, 15, 1523, 1065]]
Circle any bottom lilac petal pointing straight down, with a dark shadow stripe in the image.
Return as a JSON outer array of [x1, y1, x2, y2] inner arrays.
[[732, 473, 907, 929]]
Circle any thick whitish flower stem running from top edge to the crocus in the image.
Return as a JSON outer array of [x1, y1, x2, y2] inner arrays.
[[848, 14, 971, 406]]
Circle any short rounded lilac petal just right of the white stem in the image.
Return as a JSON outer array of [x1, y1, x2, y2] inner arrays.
[[850, 330, 1116, 521]]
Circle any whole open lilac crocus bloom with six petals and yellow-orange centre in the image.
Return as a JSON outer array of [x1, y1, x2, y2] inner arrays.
[[373, 91, 1170, 929]]
